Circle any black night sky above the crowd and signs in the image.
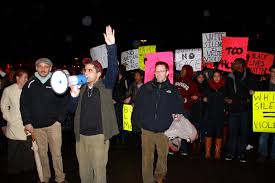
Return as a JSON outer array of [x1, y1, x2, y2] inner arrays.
[[1, 0, 275, 65]]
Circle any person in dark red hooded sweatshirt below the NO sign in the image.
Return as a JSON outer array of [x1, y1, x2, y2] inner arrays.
[[175, 65, 199, 155]]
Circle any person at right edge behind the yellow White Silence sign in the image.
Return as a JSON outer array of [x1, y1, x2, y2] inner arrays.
[[257, 65, 275, 163]]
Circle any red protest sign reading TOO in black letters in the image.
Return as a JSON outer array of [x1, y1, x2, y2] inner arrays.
[[219, 37, 248, 72]]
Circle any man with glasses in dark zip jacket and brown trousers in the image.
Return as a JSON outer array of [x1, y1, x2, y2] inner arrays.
[[132, 61, 183, 183]]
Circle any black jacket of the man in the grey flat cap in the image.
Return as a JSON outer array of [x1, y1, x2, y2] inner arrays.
[[20, 77, 67, 128]]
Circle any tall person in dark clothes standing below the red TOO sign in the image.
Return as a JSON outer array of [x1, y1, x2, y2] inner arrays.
[[225, 58, 257, 162]]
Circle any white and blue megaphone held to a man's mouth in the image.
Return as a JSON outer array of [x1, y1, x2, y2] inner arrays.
[[51, 70, 88, 95]]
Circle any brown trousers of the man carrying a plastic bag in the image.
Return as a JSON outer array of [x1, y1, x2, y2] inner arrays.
[[141, 129, 169, 183]]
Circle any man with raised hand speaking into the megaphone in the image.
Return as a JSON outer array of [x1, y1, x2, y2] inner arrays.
[[70, 26, 119, 183]]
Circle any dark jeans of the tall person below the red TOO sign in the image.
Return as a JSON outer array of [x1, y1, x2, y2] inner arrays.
[[228, 111, 248, 156]]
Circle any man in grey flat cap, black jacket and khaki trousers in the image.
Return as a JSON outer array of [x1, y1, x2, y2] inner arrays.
[[20, 58, 67, 182]]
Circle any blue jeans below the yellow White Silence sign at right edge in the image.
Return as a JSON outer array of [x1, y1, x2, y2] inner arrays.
[[259, 133, 275, 159]]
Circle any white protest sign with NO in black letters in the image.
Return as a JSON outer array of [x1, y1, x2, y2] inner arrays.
[[175, 48, 202, 72]]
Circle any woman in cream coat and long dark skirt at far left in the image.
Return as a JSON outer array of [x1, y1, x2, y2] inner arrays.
[[1, 69, 34, 174]]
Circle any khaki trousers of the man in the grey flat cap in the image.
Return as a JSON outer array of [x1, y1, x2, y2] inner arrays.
[[34, 122, 65, 182]]
